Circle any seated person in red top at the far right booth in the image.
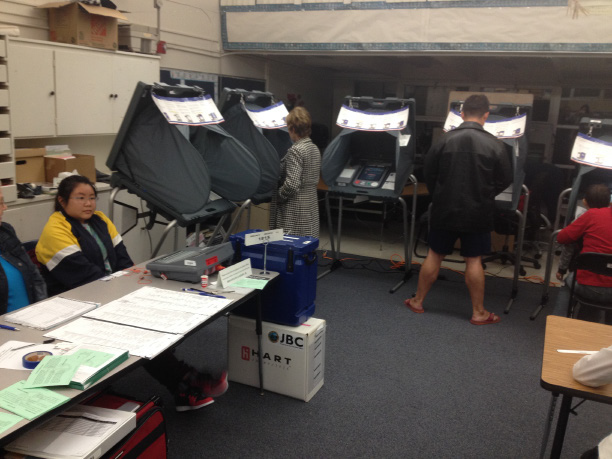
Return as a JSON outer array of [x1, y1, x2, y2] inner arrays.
[[557, 184, 612, 320]]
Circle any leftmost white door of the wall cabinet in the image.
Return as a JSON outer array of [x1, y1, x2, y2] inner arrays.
[[9, 42, 55, 137]]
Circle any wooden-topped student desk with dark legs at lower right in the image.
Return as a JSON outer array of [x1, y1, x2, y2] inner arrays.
[[540, 316, 612, 458]]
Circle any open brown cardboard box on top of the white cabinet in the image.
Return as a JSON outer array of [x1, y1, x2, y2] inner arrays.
[[38, 1, 127, 51]]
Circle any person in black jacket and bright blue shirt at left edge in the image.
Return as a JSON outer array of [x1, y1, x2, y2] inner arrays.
[[0, 190, 47, 314]]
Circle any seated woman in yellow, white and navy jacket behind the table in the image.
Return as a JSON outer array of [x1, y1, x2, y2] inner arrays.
[[36, 175, 228, 411]]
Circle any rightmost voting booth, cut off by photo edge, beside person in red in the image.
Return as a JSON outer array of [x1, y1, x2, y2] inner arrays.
[[530, 117, 612, 320]]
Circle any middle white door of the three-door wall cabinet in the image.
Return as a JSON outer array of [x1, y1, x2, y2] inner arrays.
[[55, 50, 115, 135]]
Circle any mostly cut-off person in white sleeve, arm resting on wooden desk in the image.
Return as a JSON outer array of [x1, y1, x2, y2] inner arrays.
[[573, 346, 612, 459]]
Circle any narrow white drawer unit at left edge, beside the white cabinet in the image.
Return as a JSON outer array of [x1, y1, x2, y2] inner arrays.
[[0, 35, 17, 202]]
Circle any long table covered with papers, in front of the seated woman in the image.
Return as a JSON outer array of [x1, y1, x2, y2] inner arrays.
[[0, 263, 278, 446]]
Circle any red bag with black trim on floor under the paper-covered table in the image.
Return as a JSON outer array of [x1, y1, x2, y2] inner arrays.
[[84, 393, 168, 459]]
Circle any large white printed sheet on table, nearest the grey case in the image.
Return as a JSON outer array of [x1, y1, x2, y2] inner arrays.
[[85, 287, 232, 334]]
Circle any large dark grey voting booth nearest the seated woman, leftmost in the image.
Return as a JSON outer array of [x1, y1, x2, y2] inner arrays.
[[106, 82, 262, 255]]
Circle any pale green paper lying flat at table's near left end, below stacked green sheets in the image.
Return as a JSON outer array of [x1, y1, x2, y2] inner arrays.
[[0, 381, 69, 421]]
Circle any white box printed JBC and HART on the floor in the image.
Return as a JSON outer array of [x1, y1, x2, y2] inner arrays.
[[228, 315, 326, 402]]
